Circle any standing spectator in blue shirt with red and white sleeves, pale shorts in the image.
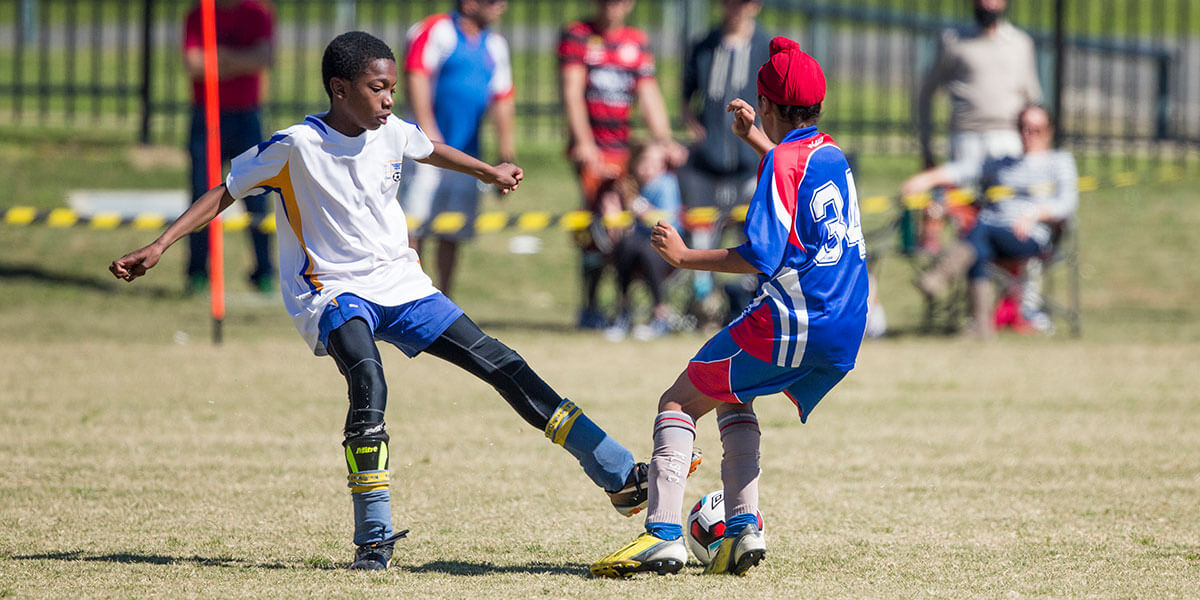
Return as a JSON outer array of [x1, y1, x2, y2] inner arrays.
[[402, 0, 516, 295]]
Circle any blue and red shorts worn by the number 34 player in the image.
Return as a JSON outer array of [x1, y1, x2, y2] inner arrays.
[[688, 328, 846, 422]]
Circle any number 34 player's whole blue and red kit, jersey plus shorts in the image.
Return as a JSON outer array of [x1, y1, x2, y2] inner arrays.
[[688, 127, 868, 419]]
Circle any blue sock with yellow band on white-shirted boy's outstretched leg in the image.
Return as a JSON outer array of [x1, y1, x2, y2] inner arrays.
[[546, 400, 634, 492]]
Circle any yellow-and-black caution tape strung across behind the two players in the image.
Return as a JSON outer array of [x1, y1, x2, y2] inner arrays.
[[0, 167, 1182, 234]]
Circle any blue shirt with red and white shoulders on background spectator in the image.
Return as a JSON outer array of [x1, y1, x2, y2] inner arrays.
[[404, 13, 512, 156]]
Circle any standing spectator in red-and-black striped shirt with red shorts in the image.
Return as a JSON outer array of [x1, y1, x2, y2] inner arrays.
[[558, 0, 688, 329]]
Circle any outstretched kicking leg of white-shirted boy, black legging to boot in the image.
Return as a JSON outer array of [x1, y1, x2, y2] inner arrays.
[[424, 316, 700, 516]]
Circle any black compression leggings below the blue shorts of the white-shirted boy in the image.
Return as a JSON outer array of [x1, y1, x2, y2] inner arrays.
[[326, 314, 562, 432]]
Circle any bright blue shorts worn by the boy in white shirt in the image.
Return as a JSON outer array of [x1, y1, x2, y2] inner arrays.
[[318, 292, 463, 358]]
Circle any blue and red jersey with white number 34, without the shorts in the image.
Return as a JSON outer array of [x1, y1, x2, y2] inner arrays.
[[730, 127, 868, 371]]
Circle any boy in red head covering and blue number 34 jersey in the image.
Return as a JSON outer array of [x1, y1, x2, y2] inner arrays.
[[592, 37, 868, 577]]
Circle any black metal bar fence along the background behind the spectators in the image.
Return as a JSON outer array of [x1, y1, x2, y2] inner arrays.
[[0, 0, 1200, 168]]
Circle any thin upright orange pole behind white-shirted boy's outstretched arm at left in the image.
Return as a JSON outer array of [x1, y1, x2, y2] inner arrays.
[[200, 0, 224, 344]]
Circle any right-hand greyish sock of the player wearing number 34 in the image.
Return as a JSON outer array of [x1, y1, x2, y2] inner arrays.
[[716, 406, 762, 520]]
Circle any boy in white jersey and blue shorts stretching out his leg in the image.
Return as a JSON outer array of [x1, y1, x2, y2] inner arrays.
[[109, 31, 698, 570]]
